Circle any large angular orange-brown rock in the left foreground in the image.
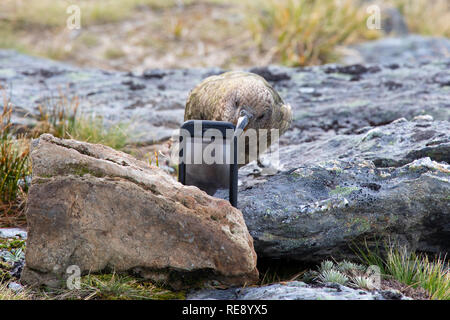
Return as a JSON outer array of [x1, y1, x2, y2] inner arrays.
[[21, 134, 258, 288]]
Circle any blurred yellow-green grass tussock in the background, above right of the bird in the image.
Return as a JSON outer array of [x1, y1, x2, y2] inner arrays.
[[248, 0, 379, 66]]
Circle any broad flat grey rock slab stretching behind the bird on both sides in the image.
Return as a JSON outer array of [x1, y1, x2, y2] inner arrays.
[[0, 46, 450, 144]]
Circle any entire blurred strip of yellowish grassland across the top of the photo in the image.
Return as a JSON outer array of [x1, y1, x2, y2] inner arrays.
[[0, 0, 450, 72]]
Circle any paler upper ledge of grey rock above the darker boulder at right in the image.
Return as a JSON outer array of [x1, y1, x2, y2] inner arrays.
[[279, 117, 450, 169]]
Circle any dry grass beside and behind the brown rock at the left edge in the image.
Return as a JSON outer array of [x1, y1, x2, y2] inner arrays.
[[0, 92, 128, 227]]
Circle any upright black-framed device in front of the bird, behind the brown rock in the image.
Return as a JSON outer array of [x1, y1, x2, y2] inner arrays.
[[178, 120, 238, 207]]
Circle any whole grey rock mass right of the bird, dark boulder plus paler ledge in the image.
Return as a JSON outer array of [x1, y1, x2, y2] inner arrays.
[[239, 117, 450, 262]]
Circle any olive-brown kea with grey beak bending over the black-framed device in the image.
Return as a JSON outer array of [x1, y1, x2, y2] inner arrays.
[[184, 71, 292, 195]]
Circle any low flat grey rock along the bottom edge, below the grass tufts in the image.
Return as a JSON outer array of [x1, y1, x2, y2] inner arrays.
[[187, 281, 409, 300]]
